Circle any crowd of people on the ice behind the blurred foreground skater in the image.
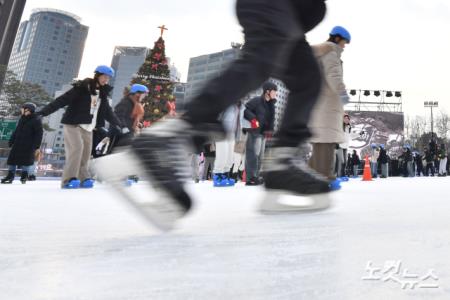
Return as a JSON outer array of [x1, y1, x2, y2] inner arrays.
[[1, 26, 449, 195]]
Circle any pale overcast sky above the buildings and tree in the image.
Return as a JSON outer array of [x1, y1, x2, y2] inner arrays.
[[23, 0, 450, 116]]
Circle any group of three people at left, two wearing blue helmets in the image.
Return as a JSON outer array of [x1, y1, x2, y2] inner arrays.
[[1, 65, 149, 185]]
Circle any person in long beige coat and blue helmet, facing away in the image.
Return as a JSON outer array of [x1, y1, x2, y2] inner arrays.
[[309, 26, 351, 180]]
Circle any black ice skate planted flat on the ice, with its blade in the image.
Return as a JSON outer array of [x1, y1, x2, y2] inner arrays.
[[260, 147, 331, 214]]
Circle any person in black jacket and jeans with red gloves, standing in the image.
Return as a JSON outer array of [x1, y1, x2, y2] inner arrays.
[[244, 81, 278, 186]]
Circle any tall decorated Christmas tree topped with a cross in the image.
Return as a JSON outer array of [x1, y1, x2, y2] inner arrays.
[[131, 25, 175, 126]]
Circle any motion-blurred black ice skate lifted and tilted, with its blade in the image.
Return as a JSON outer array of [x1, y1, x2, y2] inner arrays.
[[93, 119, 191, 230]]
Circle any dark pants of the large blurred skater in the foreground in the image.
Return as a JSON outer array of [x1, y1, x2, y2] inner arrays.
[[184, 0, 326, 147]]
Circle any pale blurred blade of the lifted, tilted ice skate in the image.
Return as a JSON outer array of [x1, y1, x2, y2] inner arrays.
[[94, 153, 186, 231]]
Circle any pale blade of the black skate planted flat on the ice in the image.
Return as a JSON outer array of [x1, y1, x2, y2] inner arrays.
[[259, 191, 331, 214]]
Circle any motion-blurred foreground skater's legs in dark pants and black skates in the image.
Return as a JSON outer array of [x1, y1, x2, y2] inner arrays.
[[97, 0, 338, 229]]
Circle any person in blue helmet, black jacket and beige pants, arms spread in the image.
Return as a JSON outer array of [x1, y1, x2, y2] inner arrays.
[[39, 66, 123, 189]]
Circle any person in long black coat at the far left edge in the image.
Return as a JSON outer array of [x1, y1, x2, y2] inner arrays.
[[1, 102, 43, 183]]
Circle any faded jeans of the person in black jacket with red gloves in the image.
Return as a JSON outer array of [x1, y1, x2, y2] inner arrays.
[[245, 132, 265, 179]]
